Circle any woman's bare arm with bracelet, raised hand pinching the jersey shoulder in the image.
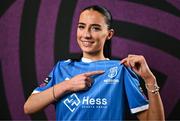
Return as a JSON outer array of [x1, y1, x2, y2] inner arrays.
[[121, 55, 165, 121]]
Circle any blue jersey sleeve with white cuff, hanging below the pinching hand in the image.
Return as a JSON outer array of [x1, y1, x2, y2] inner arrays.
[[124, 67, 149, 114]]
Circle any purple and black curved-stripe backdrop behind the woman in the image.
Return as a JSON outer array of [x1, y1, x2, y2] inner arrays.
[[0, 0, 180, 120]]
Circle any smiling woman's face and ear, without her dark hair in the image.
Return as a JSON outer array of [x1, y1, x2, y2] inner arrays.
[[77, 10, 112, 54]]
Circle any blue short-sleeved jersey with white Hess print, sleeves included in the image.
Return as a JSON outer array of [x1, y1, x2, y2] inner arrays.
[[34, 60, 148, 121]]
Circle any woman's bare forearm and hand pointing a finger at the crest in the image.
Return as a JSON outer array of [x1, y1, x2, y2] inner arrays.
[[24, 71, 104, 114]]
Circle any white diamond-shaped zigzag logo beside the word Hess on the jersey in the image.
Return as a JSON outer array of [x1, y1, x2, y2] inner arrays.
[[64, 94, 80, 112]]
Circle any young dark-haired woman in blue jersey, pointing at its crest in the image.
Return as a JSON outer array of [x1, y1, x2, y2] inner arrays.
[[24, 6, 164, 120]]
